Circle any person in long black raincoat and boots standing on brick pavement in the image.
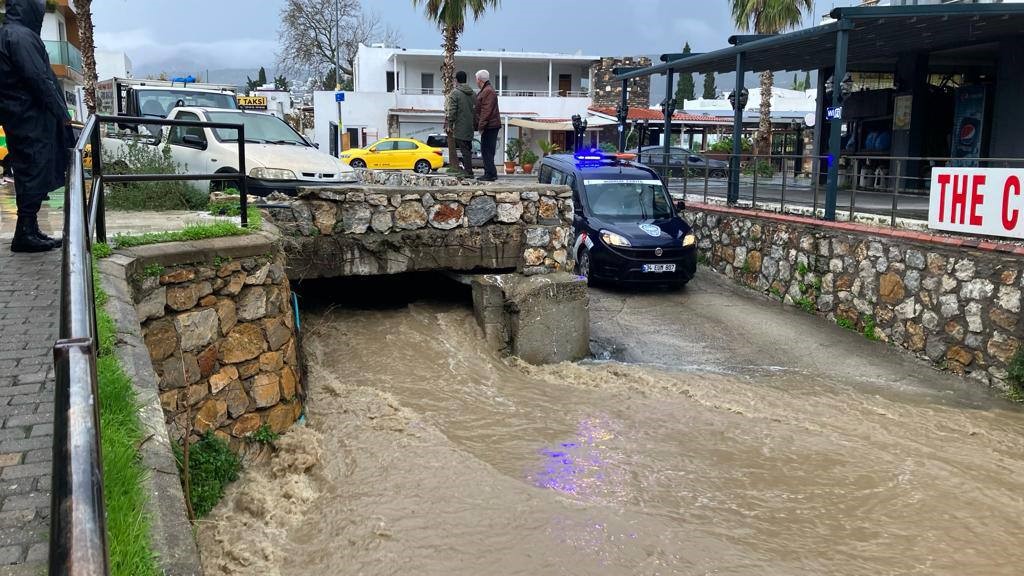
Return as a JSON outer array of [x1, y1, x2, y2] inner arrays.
[[0, 0, 73, 252]]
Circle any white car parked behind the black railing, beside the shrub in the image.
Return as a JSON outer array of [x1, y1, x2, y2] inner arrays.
[[166, 108, 355, 196]]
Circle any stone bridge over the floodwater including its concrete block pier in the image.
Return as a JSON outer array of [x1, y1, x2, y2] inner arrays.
[[265, 172, 589, 363]]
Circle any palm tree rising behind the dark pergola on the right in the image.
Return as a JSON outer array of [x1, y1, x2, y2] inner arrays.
[[729, 0, 814, 154]]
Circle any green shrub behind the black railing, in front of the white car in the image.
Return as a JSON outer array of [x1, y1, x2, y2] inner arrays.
[[103, 140, 210, 210]]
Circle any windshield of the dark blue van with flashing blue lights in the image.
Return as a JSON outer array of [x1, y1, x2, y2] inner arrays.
[[584, 180, 672, 220]]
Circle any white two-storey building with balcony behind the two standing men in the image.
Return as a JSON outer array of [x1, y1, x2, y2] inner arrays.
[[313, 45, 600, 162]]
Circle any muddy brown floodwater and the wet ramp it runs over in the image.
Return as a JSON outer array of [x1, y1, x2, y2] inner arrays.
[[199, 279, 1024, 576]]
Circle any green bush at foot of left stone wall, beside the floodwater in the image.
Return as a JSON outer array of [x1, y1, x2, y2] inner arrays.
[[174, 433, 242, 518]]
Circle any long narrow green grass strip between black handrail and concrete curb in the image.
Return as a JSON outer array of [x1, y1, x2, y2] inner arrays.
[[96, 270, 160, 576]]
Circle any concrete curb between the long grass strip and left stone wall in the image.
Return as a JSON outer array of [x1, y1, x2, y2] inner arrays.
[[97, 253, 203, 576]]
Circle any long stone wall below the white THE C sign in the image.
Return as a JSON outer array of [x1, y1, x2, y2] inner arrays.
[[687, 205, 1024, 388]]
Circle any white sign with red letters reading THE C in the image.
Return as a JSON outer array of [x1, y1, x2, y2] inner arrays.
[[928, 168, 1024, 239]]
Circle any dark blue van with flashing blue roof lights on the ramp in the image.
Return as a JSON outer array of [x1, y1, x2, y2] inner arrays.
[[538, 151, 697, 286]]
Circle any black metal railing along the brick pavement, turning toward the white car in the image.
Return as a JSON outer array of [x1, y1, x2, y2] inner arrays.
[[49, 116, 248, 576]]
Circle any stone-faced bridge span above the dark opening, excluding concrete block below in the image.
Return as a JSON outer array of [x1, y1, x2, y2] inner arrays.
[[268, 181, 574, 280]]
